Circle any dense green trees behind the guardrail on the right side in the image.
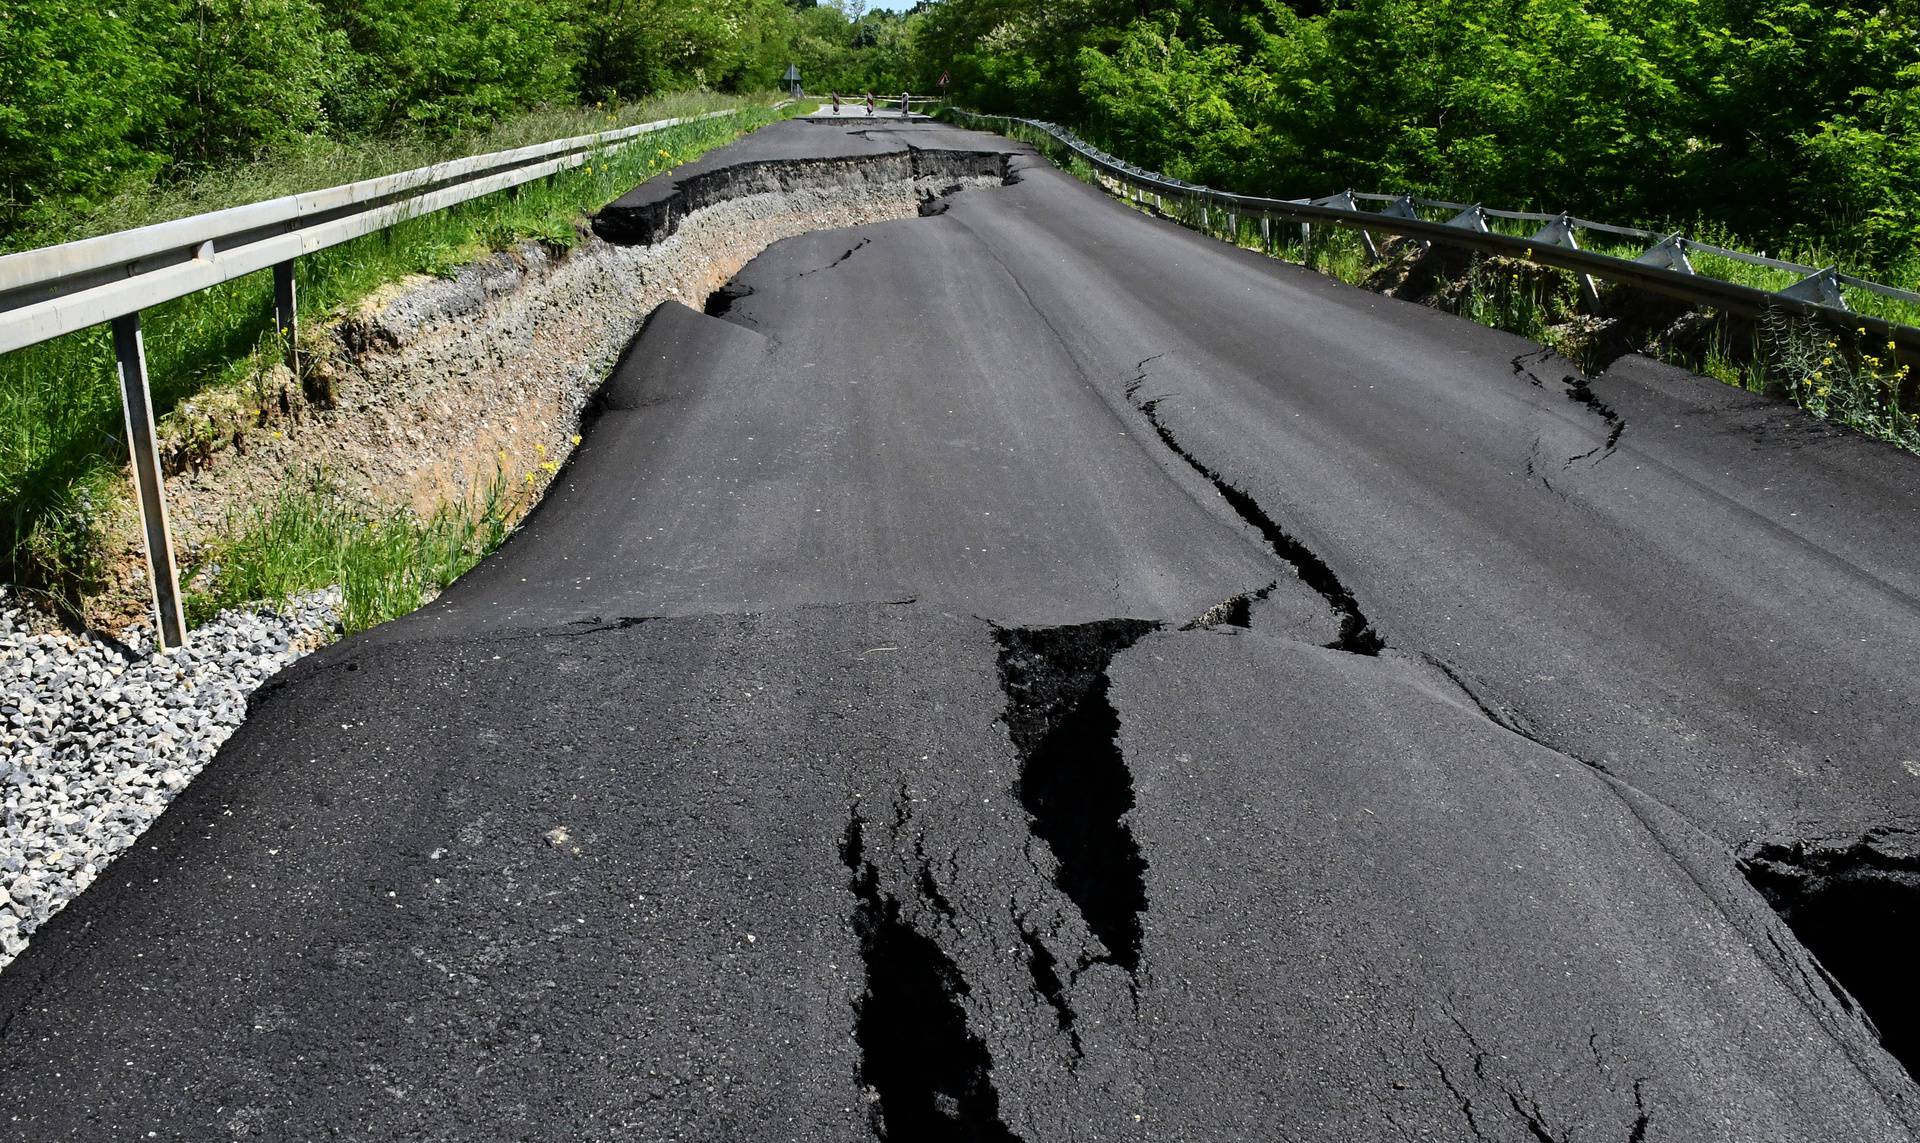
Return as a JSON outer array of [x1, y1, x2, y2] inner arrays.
[[916, 0, 1920, 273]]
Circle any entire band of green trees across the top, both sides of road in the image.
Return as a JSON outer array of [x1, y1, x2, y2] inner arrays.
[[0, 0, 1920, 273]]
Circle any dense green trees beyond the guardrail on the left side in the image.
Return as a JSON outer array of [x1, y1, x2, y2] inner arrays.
[[0, 0, 902, 232]]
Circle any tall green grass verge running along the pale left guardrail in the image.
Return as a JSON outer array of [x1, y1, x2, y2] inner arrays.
[[0, 94, 780, 619]]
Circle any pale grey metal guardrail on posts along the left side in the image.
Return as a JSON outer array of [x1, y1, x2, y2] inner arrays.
[[0, 111, 737, 649]]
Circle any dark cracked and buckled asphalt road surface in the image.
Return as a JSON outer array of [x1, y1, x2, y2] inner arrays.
[[0, 113, 1920, 1143]]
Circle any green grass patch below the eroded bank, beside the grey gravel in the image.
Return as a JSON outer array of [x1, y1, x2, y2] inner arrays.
[[186, 471, 511, 634]]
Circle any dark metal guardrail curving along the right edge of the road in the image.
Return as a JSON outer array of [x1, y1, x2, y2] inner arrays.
[[958, 111, 1920, 357]]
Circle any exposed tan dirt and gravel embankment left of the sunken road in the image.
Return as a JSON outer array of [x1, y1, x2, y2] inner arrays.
[[86, 161, 1004, 632]]
